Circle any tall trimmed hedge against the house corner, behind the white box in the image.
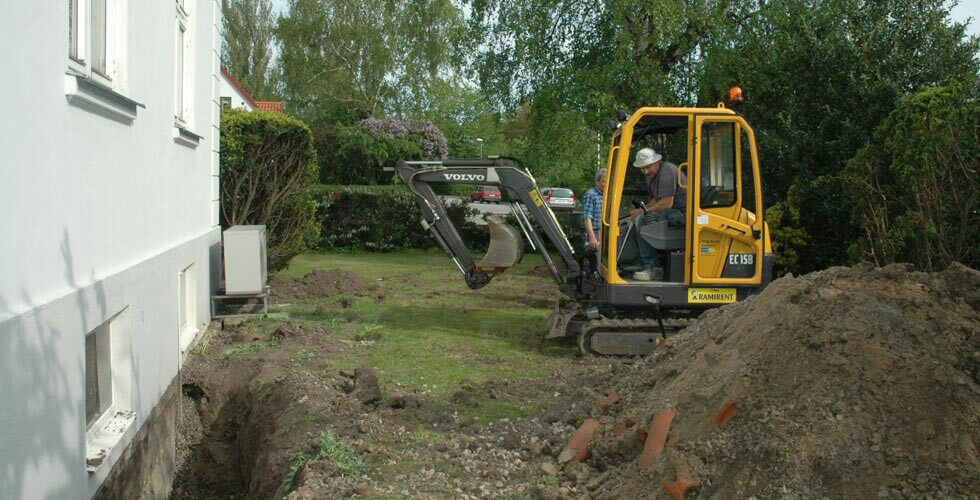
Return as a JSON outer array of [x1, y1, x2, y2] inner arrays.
[[220, 110, 319, 271]]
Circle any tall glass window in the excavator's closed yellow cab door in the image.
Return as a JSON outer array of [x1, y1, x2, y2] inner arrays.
[[701, 122, 738, 208]]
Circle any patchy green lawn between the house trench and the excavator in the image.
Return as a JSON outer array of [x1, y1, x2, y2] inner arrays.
[[272, 251, 574, 398]]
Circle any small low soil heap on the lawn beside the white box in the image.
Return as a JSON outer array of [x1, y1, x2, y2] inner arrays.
[[269, 269, 378, 303]]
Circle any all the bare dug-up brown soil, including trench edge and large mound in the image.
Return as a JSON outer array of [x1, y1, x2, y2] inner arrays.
[[174, 264, 980, 499]]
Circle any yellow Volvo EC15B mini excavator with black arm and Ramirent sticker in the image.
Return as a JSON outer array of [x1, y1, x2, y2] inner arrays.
[[396, 89, 773, 357]]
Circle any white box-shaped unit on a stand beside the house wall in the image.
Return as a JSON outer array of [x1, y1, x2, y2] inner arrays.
[[224, 226, 267, 295]]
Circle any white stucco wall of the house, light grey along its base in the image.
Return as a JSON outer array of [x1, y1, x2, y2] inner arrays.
[[0, 0, 220, 499]]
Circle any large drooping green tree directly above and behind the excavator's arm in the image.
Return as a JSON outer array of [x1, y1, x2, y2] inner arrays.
[[470, 0, 733, 197]]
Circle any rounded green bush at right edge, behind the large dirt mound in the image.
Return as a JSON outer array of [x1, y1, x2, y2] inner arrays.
[[847, 83, 980, 271]]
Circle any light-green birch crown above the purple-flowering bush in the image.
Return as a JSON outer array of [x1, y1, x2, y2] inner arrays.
[[276, 0, 463, 123]]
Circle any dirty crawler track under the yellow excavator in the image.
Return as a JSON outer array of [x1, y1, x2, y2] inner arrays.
[[578, 318, 688, 359]]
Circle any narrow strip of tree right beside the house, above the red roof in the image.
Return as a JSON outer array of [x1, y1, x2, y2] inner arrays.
[[221, 0, 277, 99]]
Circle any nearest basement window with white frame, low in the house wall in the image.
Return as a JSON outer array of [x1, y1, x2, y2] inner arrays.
[[85, 308, 136, 472]]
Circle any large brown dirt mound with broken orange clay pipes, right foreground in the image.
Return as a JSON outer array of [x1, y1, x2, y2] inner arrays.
[[579, 265, 980, 498]]
